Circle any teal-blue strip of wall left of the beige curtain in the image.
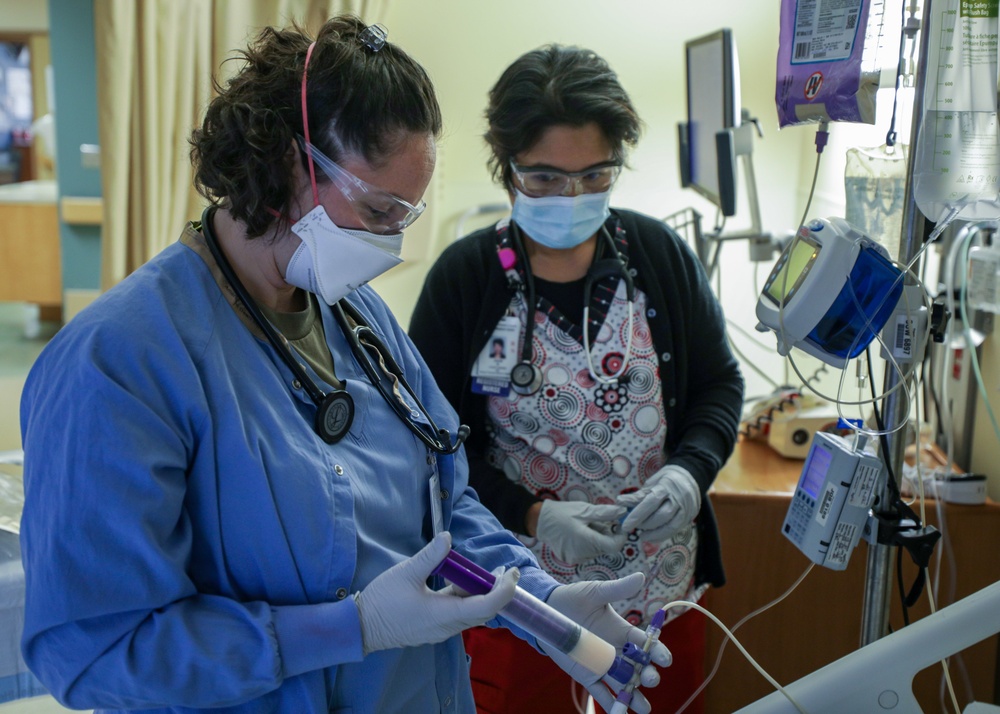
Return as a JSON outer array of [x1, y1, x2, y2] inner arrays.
[[49, 0, 101, 290]]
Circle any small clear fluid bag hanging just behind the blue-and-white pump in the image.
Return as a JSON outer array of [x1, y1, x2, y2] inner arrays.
[[844, 144, 909, 260]]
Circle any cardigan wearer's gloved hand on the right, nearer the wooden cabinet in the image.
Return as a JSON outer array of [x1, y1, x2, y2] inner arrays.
[[615, 464, 701, 541]]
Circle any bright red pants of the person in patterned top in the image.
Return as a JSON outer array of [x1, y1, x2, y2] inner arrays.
[[462, 610, 705, 714]]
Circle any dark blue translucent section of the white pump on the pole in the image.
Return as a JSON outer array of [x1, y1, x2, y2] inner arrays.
[[806, 247, 903, 359]]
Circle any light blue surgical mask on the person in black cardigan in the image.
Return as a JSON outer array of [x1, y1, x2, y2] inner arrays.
[[511, 189, 611, 250]]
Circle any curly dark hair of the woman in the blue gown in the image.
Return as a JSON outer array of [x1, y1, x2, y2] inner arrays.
[[190, 15, 441, 238]]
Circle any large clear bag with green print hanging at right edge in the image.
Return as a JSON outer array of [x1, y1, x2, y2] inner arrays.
[[913, 0, 1000, 223]]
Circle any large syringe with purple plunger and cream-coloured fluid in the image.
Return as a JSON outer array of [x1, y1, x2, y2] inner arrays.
[[434, 550, 632, 682]]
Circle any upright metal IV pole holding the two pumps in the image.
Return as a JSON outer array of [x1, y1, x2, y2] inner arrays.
[[861, 0, 932, 646]]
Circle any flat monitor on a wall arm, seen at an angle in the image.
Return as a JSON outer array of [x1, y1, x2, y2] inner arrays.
[[679, 29, 742, 216]]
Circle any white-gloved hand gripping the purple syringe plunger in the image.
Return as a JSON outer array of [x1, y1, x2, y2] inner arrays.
[[354, 532, 521, 655]]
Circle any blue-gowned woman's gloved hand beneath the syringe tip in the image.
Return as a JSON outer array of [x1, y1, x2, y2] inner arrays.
[[539, 573, 672, 714]]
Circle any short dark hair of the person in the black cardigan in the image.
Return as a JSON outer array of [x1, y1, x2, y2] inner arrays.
[[483, 45, 642, 189]]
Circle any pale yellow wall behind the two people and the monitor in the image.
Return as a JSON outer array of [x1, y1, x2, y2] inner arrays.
[[376, 0, 816, 327]]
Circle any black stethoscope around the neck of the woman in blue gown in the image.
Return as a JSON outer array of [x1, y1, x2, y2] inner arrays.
[[201, 206, 469, 454]]
